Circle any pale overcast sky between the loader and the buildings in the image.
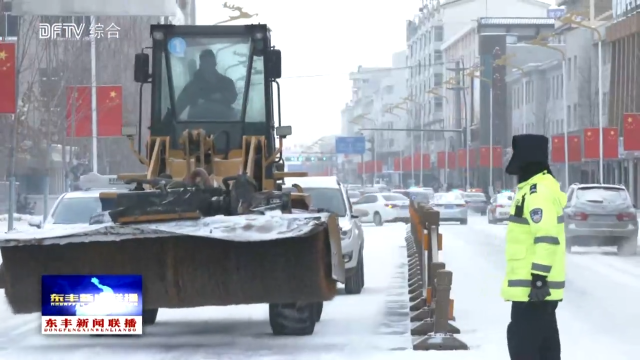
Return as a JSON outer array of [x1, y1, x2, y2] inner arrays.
[[196, 0, 551, 143]]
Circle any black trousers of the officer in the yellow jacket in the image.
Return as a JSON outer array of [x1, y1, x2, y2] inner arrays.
[[507, 301, 560, 360]]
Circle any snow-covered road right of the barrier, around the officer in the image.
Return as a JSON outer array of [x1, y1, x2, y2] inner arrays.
[[437, 216, 640, 360]]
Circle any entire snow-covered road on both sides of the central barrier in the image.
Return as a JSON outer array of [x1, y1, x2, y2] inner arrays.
[[0, 216, 640, 360]]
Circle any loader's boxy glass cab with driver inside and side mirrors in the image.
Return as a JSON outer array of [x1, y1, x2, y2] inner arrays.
[[134, 25, 281, 160]]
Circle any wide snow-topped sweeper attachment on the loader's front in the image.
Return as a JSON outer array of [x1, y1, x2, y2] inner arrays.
[[0, 213, 344, 314]]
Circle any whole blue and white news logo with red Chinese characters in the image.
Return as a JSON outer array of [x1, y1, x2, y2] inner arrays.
[[41, 275, 142, 335]]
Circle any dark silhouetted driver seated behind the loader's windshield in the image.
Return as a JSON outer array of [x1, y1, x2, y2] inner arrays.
[[176, 49, 238, 120]]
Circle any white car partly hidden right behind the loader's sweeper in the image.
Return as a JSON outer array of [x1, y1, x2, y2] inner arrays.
[[282, 176, 365, 294]]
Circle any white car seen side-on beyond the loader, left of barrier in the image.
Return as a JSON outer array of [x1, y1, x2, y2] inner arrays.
[[353, 193, 409, 226]]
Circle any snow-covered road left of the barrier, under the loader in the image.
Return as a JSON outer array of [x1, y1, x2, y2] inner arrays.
[[0, 224, 411, 360]]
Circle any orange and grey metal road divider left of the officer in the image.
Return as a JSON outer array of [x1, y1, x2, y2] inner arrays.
[[405, 201, 469, 350]]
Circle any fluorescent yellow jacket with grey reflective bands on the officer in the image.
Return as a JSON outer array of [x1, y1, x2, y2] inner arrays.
[[502, 171, 567, 301]]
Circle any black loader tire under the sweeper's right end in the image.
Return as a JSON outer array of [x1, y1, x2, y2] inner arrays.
[[269, 303, 318, 336]]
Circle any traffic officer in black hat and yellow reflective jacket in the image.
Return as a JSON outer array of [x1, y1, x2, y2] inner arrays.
[[502, 134, 567, 360]]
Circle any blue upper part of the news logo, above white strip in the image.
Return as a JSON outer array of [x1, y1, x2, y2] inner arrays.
[[42, 275, 143, 316]]
